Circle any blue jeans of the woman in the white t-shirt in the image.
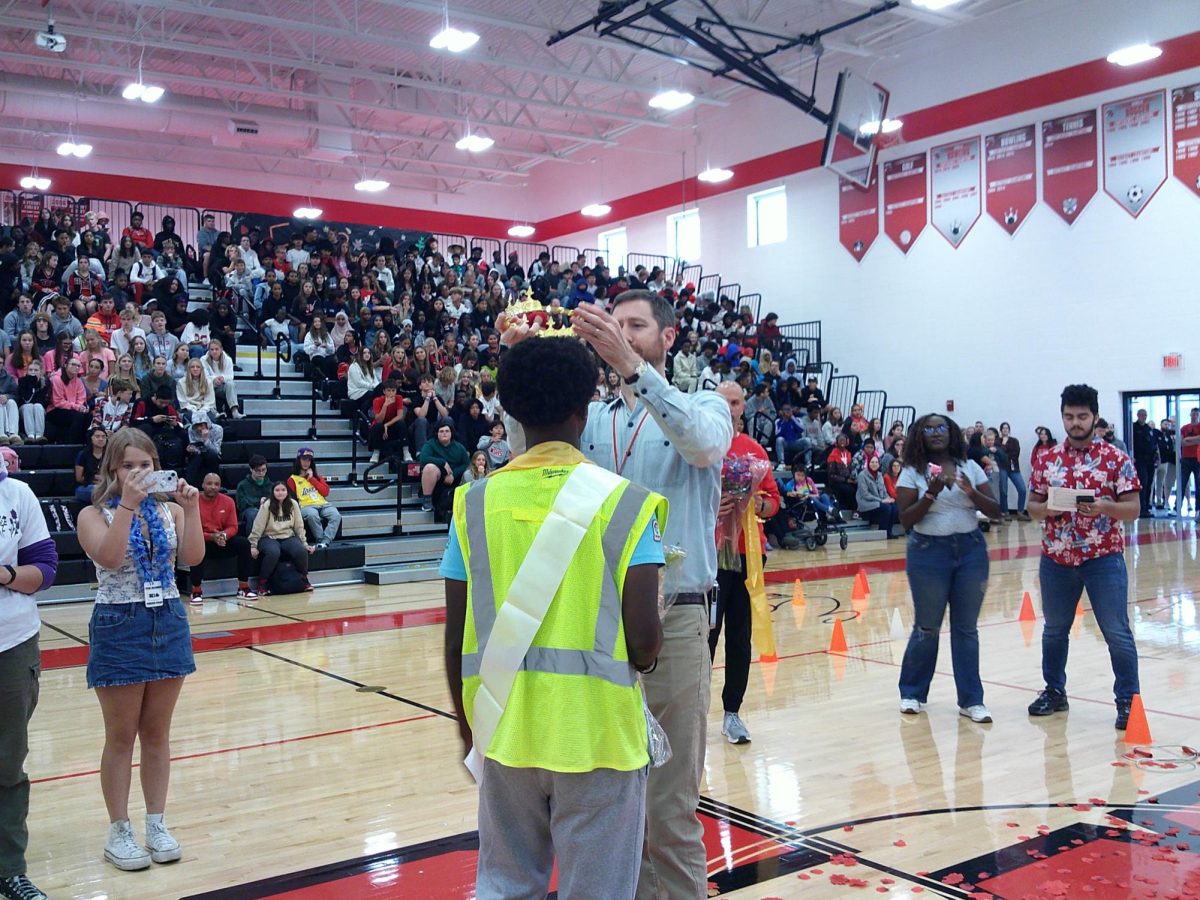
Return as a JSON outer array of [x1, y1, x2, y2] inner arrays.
[[900, 528, 988, 709]]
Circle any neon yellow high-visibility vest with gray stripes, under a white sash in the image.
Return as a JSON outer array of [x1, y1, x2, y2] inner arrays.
[[454, 444, 667, 772]]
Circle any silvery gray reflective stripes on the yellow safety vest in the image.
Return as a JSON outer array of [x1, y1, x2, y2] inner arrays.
[[462, 479, 649, 688]]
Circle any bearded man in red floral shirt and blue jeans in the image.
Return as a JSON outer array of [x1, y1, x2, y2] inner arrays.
[[1028, 384, 1141, 731]]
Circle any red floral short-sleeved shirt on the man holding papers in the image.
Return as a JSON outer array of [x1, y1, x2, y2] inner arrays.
[[1030, 439, 1141, 565]]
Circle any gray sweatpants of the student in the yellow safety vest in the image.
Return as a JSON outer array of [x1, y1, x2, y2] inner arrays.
[[475, 760, 647, 900]]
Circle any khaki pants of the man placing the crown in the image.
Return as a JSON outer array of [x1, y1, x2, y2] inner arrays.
[[637, 605, 713, 900]]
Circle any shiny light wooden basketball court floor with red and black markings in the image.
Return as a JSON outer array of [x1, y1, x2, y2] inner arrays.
[[26, 522, 1200, 900]]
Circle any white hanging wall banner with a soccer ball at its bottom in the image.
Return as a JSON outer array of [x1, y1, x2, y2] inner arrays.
[[1100, 91, 1166, 218]]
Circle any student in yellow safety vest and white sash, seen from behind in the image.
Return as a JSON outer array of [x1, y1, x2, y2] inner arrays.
[[440, 337, 667, 900]]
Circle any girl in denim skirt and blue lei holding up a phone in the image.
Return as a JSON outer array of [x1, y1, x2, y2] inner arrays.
[[79, 428, 204, 870]]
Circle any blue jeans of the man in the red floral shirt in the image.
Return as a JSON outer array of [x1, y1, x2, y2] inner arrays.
[[1038, 553, 1141, 700]]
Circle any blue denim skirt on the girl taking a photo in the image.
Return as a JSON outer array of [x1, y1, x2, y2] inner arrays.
[[88, 596, 196, 688]]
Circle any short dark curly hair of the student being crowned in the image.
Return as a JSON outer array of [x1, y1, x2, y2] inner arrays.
[[496, 337, 596, 428]]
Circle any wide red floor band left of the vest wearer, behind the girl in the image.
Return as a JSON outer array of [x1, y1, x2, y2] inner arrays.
[[42, 606, 446, 671]]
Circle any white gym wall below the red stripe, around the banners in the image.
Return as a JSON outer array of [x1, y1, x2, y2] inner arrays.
[[553, 70, 1200, 457]]
